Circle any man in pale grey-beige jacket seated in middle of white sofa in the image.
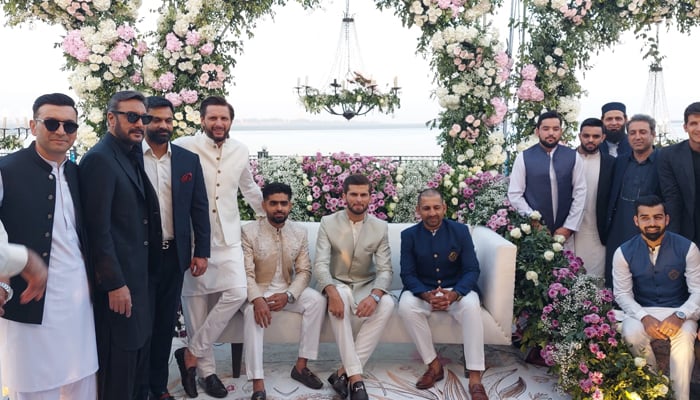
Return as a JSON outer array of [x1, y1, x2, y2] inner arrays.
[[314, 175, 394, 400]]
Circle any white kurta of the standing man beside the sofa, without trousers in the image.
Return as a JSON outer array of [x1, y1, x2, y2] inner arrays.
[[173, 133, 264, 296]]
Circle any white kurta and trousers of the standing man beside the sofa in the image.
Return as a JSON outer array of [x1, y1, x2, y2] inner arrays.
[[173, 133, 264, 378]]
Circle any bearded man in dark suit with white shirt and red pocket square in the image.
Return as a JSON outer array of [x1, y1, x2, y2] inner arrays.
[[142, 96, 210, 400]]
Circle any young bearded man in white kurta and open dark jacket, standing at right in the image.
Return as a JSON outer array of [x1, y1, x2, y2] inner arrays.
[[574, 118, 615, 278]]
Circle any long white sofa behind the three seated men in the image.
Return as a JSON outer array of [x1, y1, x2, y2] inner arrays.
[[219, 222, 516, 377]]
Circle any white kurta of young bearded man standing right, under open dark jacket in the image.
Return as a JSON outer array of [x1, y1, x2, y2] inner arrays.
[[574, 152, 605, 278]]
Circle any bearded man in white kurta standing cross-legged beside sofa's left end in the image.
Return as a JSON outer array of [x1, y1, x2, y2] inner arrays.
[[174, 96, 263, 398]]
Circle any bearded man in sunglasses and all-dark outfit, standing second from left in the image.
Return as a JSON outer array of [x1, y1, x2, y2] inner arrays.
[[80, 91, 162, 400]]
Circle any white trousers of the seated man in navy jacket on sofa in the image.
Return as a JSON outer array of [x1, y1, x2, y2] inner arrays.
[[399, 291, 486, 371]]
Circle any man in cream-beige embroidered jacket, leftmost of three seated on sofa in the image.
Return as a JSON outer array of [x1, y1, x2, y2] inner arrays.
[[241, 182, 326, 400]]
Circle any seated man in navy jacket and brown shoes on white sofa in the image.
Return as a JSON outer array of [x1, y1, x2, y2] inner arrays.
[[399, 189, 488, 400]]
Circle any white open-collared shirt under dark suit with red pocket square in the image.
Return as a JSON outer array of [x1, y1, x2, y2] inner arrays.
[[141, 140, 175, 240]]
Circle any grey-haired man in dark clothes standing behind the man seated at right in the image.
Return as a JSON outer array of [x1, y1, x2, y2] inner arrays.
[[605, 114, 661, 288]]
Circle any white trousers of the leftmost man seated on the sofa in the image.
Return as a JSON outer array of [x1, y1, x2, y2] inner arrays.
[[243, 288, 326, 379]]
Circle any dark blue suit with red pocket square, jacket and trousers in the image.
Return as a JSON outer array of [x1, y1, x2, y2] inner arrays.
[[146, 144, 211, 395]]
